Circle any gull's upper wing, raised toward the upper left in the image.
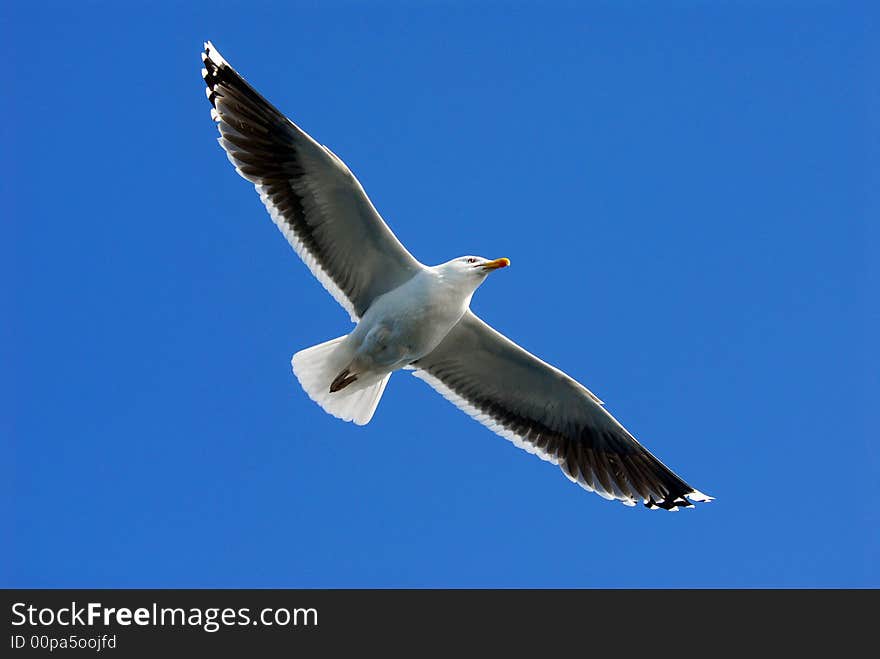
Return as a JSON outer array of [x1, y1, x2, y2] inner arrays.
[[202, 42, 423, 320]]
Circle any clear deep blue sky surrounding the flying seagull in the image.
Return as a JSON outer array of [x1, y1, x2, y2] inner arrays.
[[0, 1, 880, 587]]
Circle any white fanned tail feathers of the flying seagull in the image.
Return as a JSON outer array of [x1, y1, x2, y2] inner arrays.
[[290, 336, 390, 426]]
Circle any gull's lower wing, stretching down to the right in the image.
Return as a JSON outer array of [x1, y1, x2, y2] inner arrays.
[[413, 311, 711, 510]]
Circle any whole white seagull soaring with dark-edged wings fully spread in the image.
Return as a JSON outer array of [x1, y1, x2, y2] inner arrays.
[[202, 41, 712, 511]]
